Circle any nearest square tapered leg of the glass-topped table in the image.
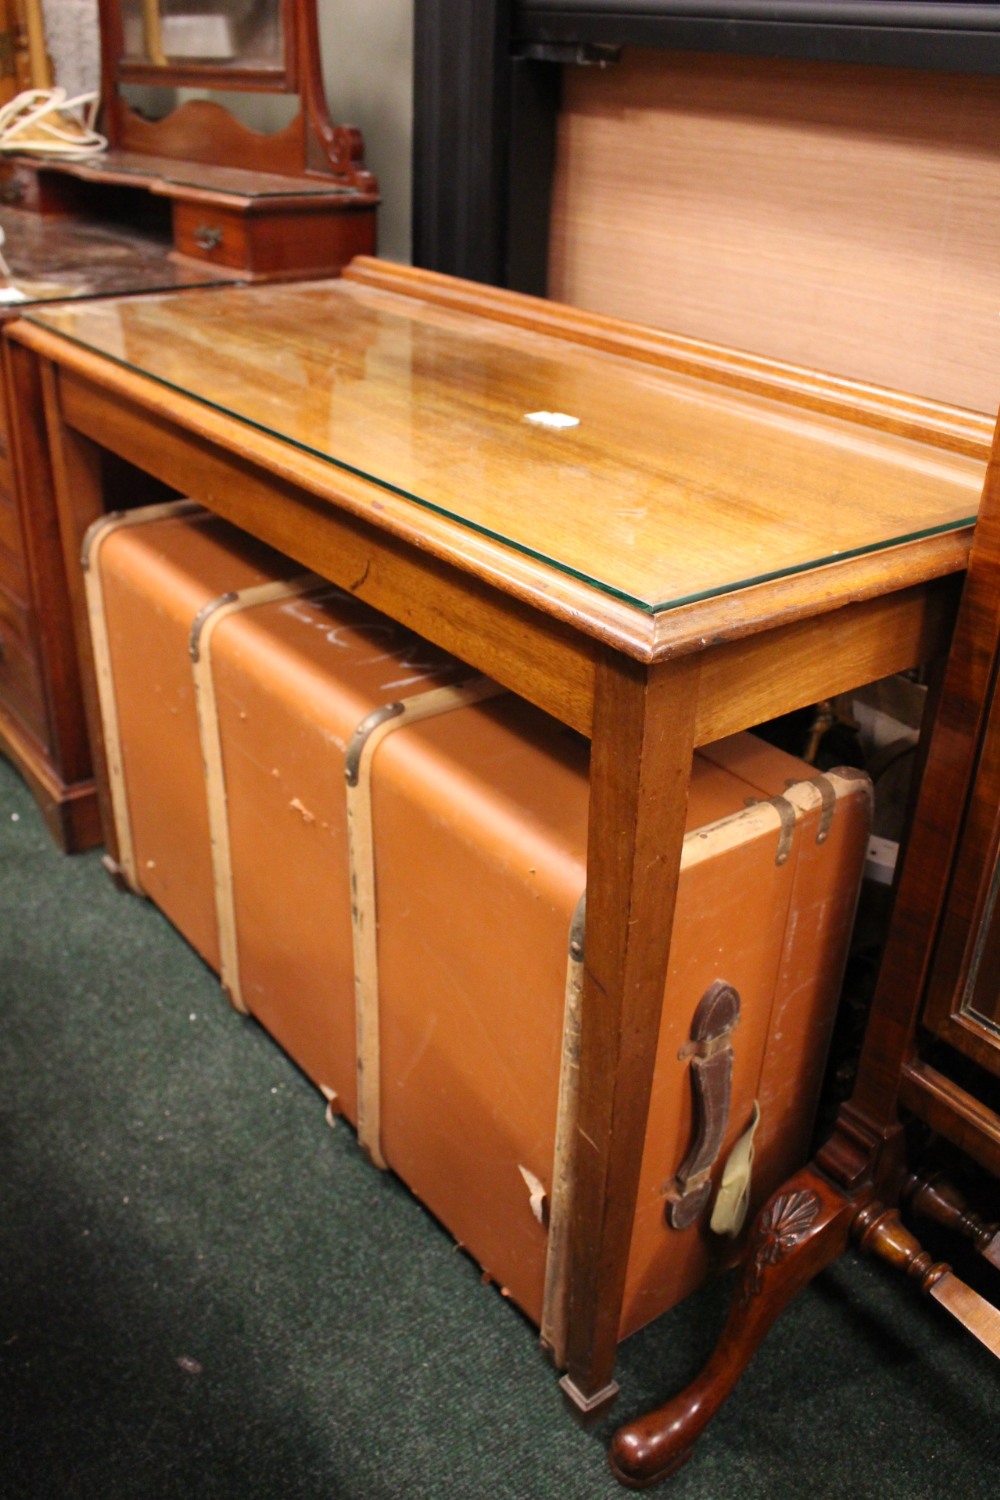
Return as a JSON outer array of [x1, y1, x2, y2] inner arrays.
[[562, 653, 700, 1415]]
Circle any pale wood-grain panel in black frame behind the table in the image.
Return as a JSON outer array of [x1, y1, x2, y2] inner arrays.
[[549, 51, 1000, 413]]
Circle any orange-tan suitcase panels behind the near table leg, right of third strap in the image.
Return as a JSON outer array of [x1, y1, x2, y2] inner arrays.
[[375, 699, 868, 1335]]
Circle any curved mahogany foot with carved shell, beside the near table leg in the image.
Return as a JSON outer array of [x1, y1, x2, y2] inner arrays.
[[609, 1169, 858, 1490]]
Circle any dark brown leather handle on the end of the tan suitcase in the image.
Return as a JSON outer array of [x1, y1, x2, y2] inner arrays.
[[666, 980, 739, 1229]]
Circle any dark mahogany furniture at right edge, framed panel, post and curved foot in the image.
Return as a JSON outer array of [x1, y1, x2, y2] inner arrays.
[[610, 414, 1000, 1488]]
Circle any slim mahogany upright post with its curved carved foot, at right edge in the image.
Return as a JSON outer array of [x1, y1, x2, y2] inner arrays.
[[610, 429, 1000, 1485]]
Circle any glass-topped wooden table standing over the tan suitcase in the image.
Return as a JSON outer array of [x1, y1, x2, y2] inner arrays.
[[6, 261, 993, 1412]]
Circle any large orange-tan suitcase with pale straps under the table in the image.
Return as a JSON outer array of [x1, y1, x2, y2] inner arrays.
[[88, 515, 870, 1361]]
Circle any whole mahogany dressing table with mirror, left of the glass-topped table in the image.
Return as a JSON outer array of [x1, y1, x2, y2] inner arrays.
[[0, 0, 378, 851]]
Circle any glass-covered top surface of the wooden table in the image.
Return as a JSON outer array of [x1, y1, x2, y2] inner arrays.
[[28, 281, 985, 614]]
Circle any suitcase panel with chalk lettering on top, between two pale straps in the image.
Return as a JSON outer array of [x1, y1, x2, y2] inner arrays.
[[213, 588, 471, 1121]]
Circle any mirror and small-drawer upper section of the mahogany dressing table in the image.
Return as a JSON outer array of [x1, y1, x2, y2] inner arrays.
[[0, 0, 378, 279]]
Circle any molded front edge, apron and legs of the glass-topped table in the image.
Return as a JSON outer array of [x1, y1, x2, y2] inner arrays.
[[7, 273, 979, 1415]]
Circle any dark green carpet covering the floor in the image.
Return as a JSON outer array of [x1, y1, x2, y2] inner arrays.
[[0, 761, 1000, 1500]]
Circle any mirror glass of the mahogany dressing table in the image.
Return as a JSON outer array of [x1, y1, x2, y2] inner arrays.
[[121, 0, 285, 71]]
